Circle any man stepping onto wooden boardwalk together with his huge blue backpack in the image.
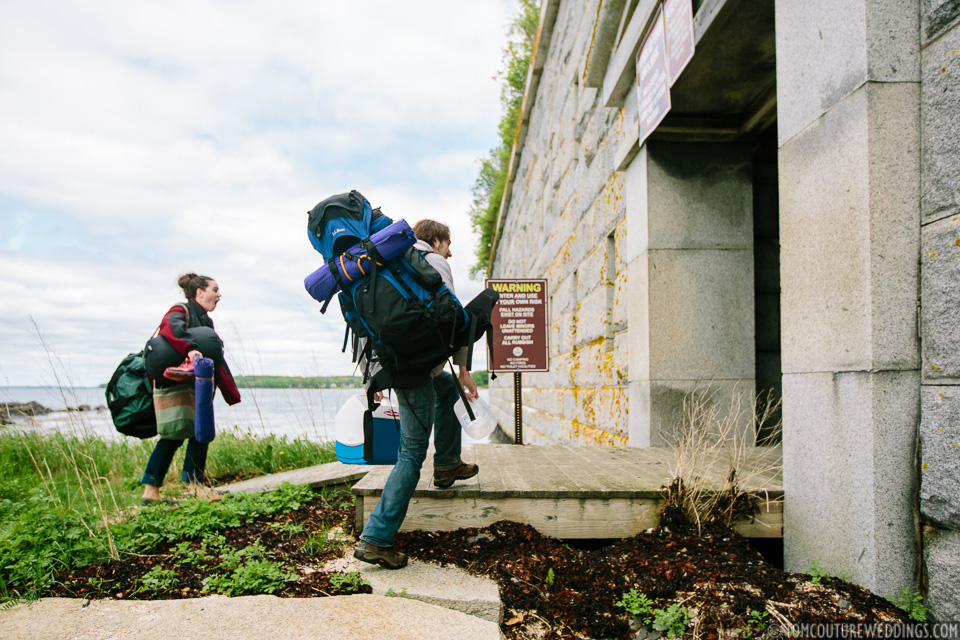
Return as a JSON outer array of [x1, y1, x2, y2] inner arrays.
[[304, 191, 498, 569]]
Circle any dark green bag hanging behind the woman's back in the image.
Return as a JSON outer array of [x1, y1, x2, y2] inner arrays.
[[106, 351, 157, 438]]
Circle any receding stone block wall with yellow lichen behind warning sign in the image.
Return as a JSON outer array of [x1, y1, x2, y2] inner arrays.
[[490, 0, 628, 445]]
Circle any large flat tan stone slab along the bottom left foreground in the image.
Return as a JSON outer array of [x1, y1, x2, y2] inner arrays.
[[0, 595, 502, 640]]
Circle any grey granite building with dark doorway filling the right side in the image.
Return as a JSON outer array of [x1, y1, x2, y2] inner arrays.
[[490, 0, 960, 620]]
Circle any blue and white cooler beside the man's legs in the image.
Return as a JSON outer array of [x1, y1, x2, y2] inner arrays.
[[334, 393, 400, 464]]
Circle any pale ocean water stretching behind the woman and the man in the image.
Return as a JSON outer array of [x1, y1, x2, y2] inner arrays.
[[0, 387, 488, 444]]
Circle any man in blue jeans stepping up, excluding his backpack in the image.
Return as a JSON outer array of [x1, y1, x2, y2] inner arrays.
[[354, 220, 479, 569]]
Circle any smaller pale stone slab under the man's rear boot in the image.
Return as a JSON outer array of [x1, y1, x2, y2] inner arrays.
[[323, 545, 503, 624]]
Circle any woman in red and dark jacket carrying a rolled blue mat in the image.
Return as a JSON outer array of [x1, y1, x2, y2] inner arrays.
[[140, 273, 240, 505]]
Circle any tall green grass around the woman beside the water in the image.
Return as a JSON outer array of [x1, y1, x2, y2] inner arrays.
[[0, 322, 344, 602]]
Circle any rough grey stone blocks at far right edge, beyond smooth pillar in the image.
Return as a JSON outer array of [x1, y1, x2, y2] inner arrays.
[[920, 0, 960, 620]]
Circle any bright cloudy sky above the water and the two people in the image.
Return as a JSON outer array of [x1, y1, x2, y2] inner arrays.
[[0, 0, 515, 387]]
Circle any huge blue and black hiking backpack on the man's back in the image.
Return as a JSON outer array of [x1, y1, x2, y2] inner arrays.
[[304, 191, 479, 388]]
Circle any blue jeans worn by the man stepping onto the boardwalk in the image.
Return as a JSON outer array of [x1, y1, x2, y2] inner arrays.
[[360, 371, 460, 547]]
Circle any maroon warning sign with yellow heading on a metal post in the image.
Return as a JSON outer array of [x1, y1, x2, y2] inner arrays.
[[484, 280, 550, 373]]
